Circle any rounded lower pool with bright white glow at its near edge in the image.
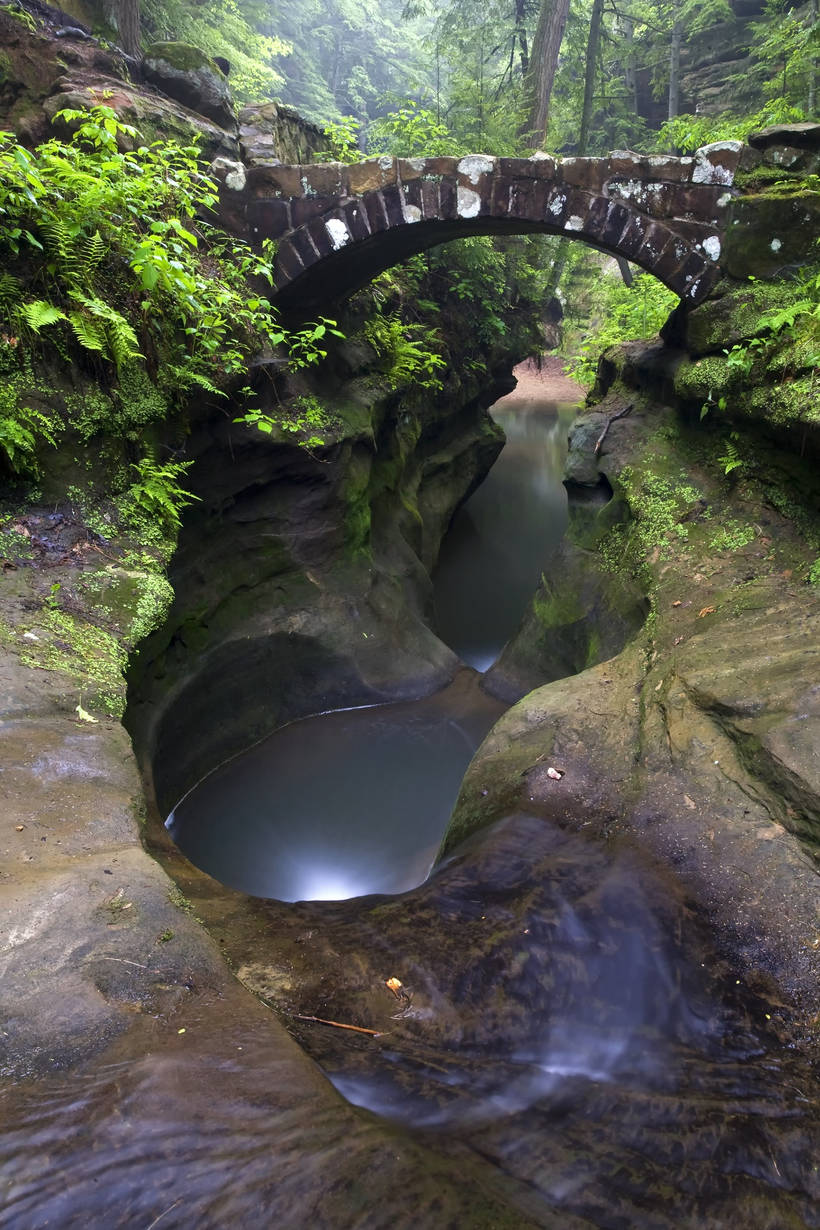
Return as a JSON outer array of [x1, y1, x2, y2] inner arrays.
[[167, 672, 504, 902]]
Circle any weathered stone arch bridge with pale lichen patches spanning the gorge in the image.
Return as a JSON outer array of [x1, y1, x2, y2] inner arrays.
[[211, 141, 744, 312]]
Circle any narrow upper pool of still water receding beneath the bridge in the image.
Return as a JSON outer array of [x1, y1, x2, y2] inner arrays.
[[434, 397, 578, 672]]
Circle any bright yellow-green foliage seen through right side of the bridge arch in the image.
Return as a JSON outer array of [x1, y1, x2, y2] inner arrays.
[[567, 273, 677, 385]]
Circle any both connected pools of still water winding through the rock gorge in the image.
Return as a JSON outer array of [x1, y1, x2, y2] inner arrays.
[[167, 397, 574, 902]]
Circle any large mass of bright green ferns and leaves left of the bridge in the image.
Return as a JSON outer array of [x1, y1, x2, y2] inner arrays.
[[0, 106, 339, 462]]
